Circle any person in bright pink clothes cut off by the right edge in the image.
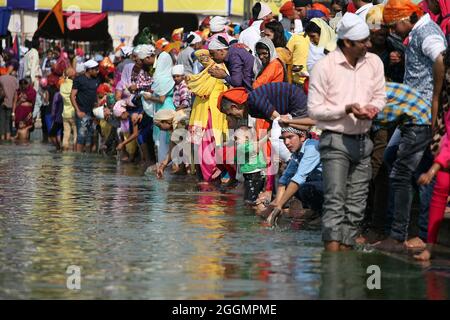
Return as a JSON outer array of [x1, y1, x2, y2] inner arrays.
[[414, 49, 450, 261]]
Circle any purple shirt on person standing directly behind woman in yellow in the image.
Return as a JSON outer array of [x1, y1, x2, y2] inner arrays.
[[224, 46, 255, 91]]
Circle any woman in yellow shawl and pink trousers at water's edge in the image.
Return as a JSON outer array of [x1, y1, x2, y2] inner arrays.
[[186, 50, 228, 182]]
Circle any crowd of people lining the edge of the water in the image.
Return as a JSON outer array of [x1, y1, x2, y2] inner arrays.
[[0, 0, 450, 260]]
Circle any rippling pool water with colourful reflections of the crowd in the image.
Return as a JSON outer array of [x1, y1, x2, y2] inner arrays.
[[0, 144, 450, 299]]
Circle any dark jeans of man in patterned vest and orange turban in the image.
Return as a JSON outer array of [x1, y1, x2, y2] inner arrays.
[[390, 126, 432, 241]]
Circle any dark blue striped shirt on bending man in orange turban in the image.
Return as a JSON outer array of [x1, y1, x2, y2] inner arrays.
[[247, 82, 308, 121]]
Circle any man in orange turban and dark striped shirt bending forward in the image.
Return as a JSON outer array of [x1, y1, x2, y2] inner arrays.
[[218, 82, 308, 121]]
